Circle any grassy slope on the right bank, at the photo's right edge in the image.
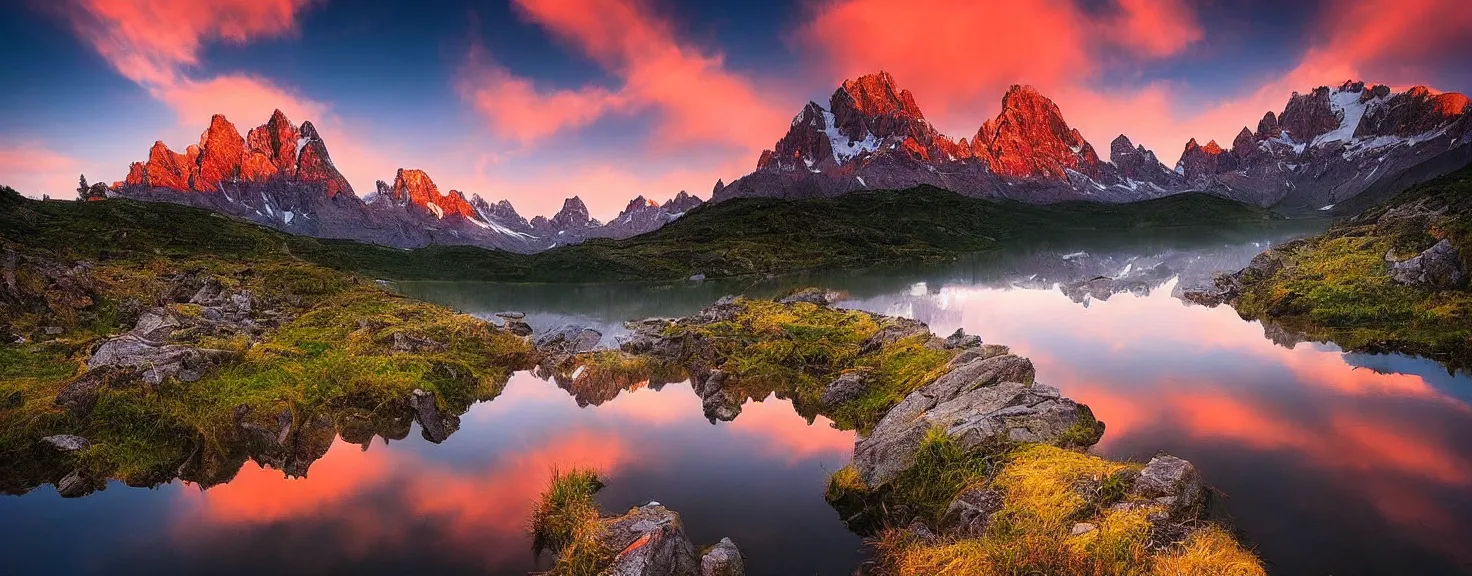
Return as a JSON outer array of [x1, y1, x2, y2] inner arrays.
[[1236, 166, 1472, 367]]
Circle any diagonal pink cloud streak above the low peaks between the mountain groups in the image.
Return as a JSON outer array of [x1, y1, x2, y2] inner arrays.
[[461, 0, 788, 155]]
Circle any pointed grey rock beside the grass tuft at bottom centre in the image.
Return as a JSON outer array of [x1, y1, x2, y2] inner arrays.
[[599, 502, 701, 576]]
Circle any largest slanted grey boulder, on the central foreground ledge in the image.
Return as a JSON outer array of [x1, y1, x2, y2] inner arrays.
[[854, 355, 1104, 488]]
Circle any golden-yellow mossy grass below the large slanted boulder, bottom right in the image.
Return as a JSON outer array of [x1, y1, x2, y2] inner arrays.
[[874, 447, 1264, 576]]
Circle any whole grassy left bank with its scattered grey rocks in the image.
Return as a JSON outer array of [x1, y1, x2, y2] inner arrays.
[[0, 187, 531, 495]]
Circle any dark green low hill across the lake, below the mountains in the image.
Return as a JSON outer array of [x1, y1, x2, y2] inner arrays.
[[293, 187, 1275, 281]]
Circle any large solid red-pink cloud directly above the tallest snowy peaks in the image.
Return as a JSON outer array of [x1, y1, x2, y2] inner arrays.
[[798, 0, 1203, 137]]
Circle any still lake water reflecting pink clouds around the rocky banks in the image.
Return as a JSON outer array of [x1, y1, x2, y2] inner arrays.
[[0, 230, 1472, 576]]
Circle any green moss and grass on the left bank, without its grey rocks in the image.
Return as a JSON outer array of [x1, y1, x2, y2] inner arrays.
[[0, 190, 533, 491]]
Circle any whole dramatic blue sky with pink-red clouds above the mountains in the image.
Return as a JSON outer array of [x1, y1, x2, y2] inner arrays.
[[0, 0, 1472, 218]]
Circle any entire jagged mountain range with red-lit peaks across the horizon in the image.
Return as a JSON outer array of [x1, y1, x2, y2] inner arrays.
[[109, 72, 1472, 253]]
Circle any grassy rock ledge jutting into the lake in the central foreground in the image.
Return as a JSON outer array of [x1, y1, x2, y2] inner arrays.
[[603, 296, 1262, 575]]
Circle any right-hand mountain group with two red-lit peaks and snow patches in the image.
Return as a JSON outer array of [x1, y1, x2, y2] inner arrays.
[[712, 72, 1472, 211]]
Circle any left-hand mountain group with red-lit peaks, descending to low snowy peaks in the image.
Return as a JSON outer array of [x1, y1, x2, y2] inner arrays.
[[109, 110, 702, 253]]
